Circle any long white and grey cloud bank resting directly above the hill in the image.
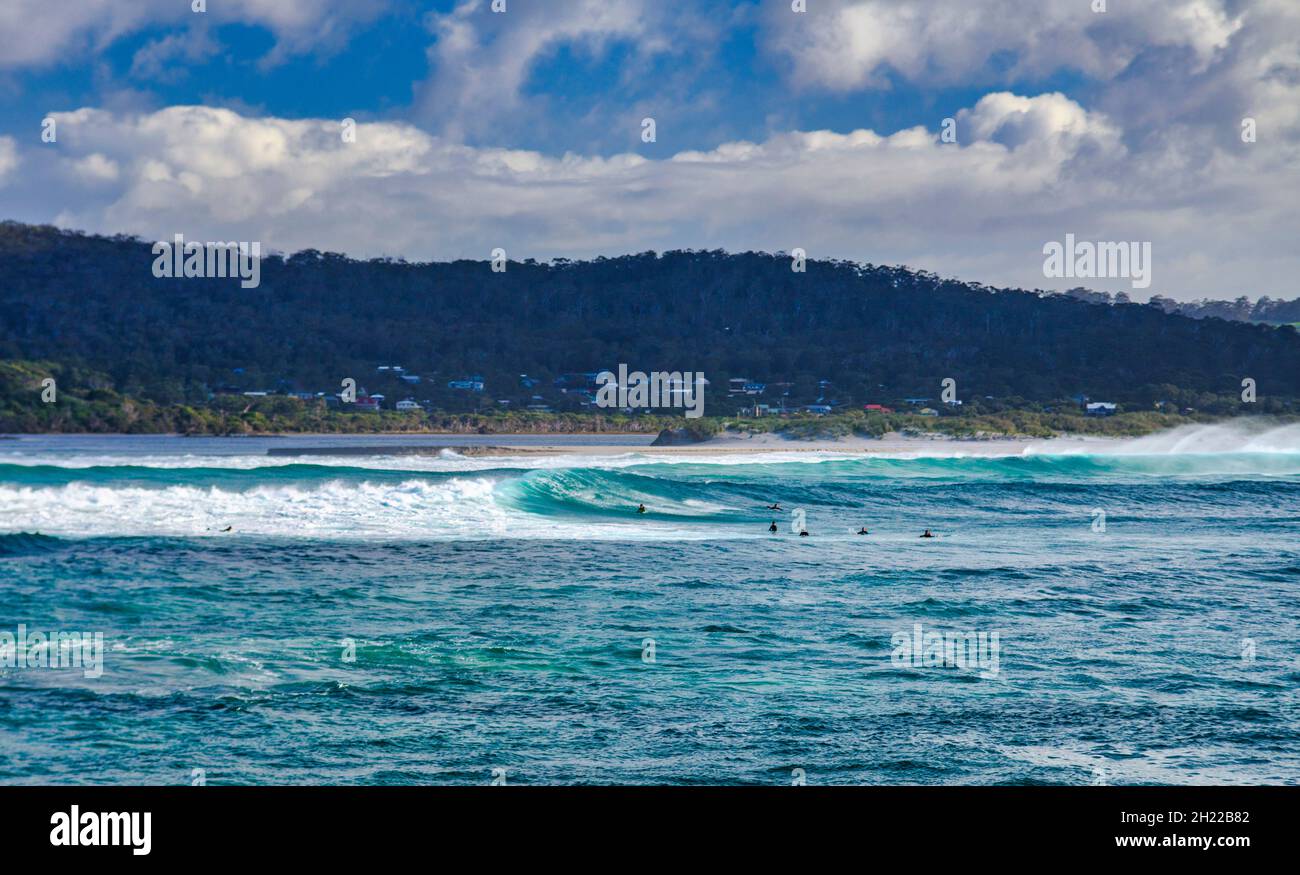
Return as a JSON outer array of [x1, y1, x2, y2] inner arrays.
[[0, 92, 1300, 298]]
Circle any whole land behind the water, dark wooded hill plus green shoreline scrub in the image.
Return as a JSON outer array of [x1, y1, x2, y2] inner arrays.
[[0, 222, 1300, 439]]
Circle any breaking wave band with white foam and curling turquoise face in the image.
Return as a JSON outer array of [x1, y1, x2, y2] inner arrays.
[[0, 424, 1300, 535]]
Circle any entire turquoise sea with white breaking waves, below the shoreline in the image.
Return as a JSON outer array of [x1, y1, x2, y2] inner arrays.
[[0, 429, 1300, 784]]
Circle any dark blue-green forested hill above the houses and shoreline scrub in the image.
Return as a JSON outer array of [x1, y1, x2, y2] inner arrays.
[[0, 222, 1300, 406]]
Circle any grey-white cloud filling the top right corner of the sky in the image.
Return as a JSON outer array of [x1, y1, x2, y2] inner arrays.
[[764, 0, 1300, 160]]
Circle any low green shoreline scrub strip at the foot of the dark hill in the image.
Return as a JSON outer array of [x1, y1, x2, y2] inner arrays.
[[0, 361, 1258, 442]]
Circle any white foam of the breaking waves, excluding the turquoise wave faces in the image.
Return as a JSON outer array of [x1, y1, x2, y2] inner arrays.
[[0, 420, 1300, 541]]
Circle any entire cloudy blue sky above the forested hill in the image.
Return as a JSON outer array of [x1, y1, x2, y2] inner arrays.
[[0, 0, 1300, 299]]
